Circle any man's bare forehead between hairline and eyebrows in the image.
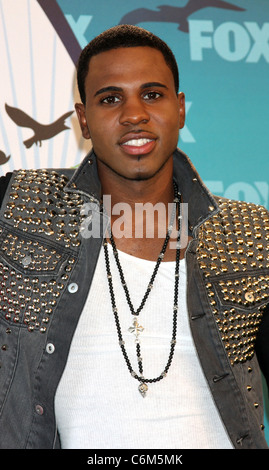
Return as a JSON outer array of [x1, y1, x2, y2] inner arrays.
[[85, 46, 174, 94]]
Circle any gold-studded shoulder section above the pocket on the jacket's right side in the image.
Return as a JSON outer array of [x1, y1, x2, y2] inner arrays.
[[197, 197, 269, 276]]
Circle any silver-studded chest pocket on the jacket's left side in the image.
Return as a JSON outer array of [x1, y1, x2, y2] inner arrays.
[[0, 230, 75, 333]]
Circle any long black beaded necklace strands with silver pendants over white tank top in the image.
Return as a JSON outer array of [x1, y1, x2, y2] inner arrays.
[[104, 183, 181, 397]]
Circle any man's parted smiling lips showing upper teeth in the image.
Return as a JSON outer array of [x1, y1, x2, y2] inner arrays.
[[119, 132, 157, 155]]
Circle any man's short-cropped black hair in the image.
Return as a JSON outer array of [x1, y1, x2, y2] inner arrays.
[[77, 25, 179, 104]]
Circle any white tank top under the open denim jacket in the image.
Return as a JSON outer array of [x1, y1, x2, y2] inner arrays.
[[55, 245, 232, 449]]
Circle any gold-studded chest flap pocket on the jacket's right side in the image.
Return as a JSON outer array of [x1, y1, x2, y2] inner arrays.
[[204, 271, 269, 365]]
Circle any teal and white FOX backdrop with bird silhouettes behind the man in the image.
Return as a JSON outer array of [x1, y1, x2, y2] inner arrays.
[[0, 0, 269, 442]]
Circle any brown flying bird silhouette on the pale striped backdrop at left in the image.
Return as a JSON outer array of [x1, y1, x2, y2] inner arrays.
[[5, 104, 74, 148]]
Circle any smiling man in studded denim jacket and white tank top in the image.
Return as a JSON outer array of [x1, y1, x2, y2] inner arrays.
[[0, 26, 269, 449]]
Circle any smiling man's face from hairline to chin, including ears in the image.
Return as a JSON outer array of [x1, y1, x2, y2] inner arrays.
[[76, 47, 185, 180]]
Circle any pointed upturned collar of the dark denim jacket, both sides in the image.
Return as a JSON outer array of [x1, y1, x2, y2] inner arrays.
[[65, 149, 219, 230]]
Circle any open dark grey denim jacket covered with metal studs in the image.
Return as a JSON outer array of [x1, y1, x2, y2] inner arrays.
[[0, 150, 269, 449]]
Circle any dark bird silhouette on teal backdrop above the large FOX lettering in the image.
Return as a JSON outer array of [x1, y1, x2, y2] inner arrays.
[[119, 0, 245, 33]]
